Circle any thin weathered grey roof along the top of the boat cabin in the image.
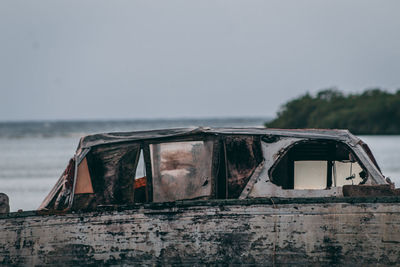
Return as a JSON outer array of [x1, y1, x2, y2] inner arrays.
[[78, 127, 359, 149]]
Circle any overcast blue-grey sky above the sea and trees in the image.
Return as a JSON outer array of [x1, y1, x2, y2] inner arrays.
[[0, 0, 400, 120]]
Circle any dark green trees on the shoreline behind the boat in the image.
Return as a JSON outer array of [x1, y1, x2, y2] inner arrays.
[[265, 89, 400, 135]]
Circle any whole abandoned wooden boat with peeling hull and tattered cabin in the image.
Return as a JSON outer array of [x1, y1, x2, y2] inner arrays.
[[0, 128, 400, 266]]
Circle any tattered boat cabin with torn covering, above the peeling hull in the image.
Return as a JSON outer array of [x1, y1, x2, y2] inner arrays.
[[39, 128, 394, 214]]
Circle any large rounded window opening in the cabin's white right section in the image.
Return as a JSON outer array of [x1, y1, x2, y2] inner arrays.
[[271, 141, 367, 189]]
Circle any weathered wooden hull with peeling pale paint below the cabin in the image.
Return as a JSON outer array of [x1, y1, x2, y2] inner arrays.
[[0, 197, 400, 266]]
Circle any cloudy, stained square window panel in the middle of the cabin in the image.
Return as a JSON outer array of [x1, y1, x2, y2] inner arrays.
[[150, 141, 213, 202]]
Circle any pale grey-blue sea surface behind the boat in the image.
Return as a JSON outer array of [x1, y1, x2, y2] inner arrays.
[[0, 118, 400, 211]]
